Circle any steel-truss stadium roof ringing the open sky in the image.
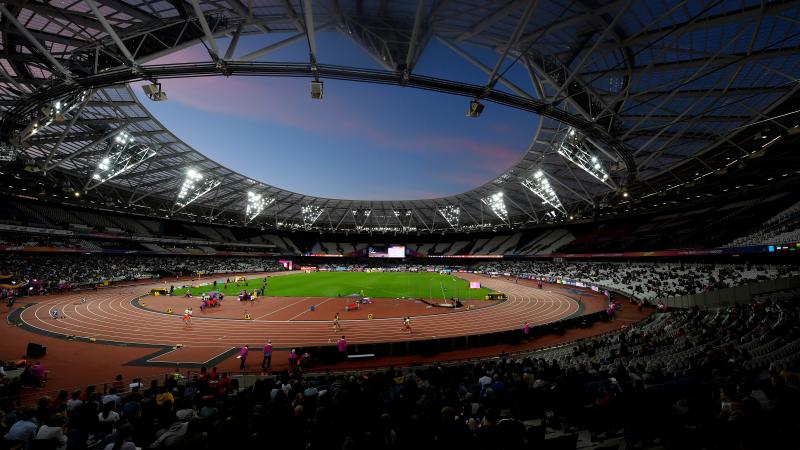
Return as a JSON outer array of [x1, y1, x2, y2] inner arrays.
[[0, 0, 800, 232]]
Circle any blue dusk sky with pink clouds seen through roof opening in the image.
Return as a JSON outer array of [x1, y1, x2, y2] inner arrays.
[[142, 32, 539, 200]]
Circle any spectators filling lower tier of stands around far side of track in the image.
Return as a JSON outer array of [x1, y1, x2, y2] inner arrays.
[[6, 253, 800, 302]]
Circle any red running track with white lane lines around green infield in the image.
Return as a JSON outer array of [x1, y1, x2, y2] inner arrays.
[[21, 274, 579, 350]]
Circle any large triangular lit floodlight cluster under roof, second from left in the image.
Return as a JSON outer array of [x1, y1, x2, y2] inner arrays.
[[86, 131, 158, 191]]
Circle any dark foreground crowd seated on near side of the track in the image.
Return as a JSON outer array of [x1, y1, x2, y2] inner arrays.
[[0, 299, 800, 450]]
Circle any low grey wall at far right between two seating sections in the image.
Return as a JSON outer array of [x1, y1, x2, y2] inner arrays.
[[664, 277, 800, 309]]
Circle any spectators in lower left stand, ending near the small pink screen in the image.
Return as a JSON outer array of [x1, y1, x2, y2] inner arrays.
[[0, 253, 283, 293]]
